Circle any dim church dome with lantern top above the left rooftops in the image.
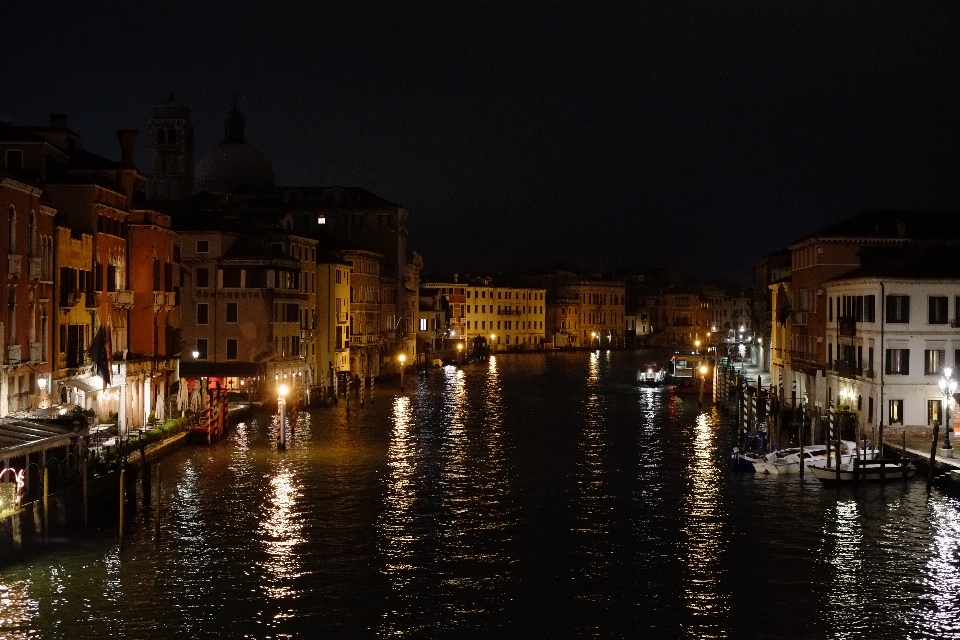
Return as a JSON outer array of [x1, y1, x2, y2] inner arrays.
[[195, 108, 276, 193]]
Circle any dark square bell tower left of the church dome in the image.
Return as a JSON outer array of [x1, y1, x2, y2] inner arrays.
[[147, 93, 193, 200]]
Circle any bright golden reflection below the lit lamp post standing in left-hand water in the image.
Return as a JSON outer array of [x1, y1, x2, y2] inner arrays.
[[260, 460, 304, 598]]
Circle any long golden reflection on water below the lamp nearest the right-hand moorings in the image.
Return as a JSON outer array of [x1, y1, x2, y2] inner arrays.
[[683, 413, 729, 638]]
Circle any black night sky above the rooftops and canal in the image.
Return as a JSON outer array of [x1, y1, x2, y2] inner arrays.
[[0, 0, 960, 282]]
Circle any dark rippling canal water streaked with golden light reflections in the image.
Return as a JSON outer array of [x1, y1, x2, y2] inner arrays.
[[0, 352, 960, 639]]
